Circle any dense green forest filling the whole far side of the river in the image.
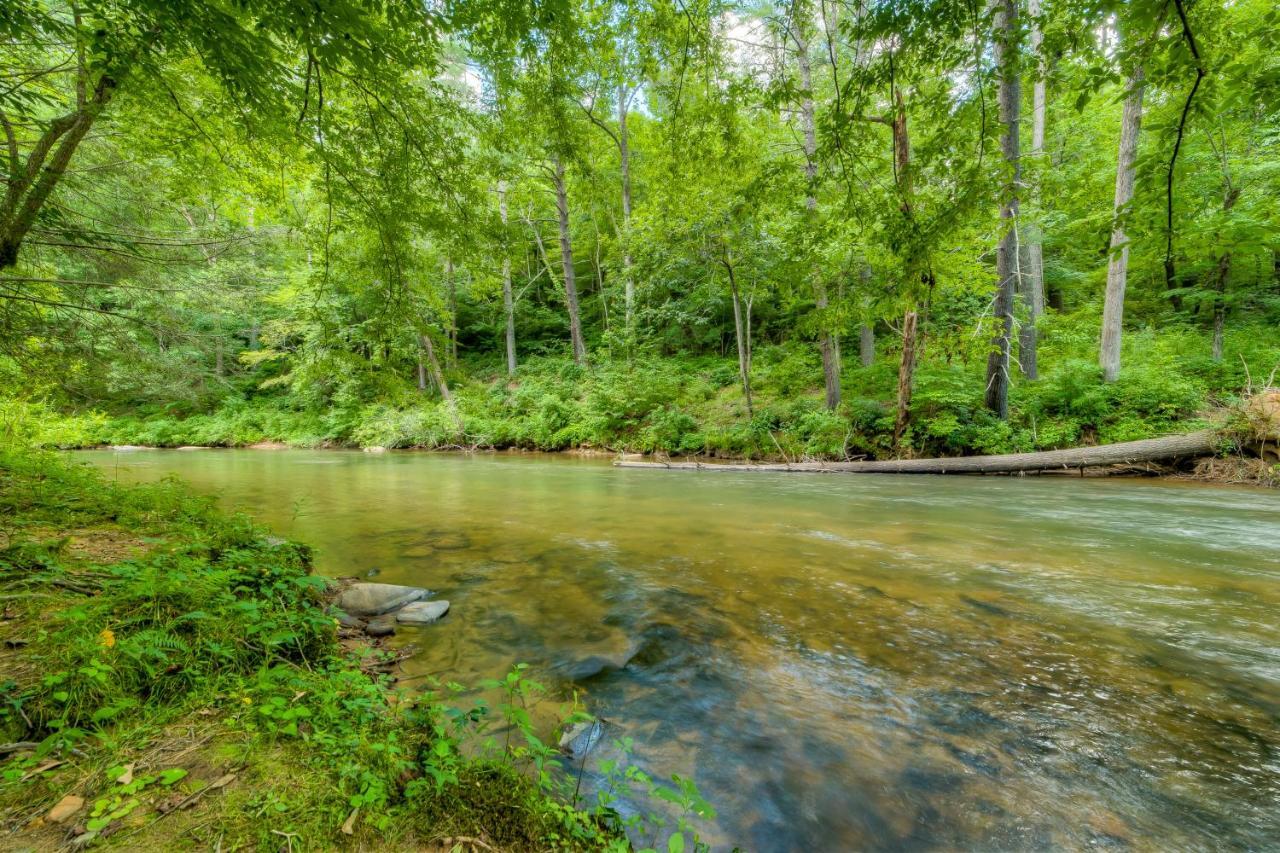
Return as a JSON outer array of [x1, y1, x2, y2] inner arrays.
[[0, 0, 1280, 459]]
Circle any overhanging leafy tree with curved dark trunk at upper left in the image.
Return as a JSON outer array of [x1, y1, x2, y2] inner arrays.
[[0, 0, 436, 270]]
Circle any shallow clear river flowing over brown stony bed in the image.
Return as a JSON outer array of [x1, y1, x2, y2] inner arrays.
[[82, 450, 1280, 850]]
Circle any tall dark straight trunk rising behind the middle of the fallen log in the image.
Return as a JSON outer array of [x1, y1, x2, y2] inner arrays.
[[986, 0, 1021, 420]]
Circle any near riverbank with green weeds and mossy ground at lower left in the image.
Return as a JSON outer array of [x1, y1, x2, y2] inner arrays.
[[0, 450, 709, 849]]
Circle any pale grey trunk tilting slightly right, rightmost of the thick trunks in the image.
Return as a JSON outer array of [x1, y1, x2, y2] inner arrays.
[[1098, 65, 1146, 382]]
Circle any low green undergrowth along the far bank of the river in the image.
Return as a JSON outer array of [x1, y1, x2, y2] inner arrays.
[[0, 318, 1280, 460]]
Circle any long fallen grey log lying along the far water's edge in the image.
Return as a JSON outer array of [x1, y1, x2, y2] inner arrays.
[[614, 429, 1220, 474]]
